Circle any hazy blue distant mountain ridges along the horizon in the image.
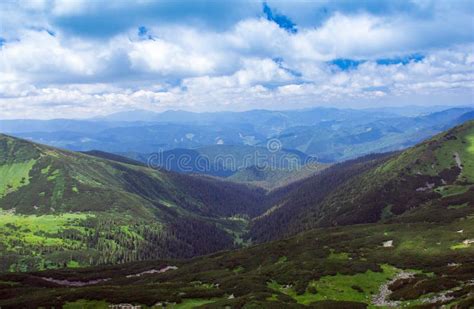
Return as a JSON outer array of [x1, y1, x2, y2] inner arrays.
[[0, 108, 474, 162]]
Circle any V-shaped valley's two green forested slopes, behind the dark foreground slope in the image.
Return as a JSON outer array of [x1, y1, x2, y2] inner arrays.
[[0, 122, 474, 271]]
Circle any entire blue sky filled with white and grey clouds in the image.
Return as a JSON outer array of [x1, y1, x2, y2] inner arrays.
[[0, 0, 474, 119]]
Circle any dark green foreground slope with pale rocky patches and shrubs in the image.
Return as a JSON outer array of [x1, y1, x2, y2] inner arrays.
[[0, 209, 474, 309]]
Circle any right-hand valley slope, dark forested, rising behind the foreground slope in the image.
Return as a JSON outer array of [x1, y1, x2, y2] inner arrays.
[[250, 121, 474, 241]]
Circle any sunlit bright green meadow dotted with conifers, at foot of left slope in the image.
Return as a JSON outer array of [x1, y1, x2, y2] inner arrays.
[[0, 211, 189, 272]]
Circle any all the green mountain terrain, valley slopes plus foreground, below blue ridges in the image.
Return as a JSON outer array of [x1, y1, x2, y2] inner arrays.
[[0, 121, 474, 308]]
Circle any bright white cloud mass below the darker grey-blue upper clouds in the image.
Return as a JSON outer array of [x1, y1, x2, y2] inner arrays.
[[0, 1, 474, 118]]
